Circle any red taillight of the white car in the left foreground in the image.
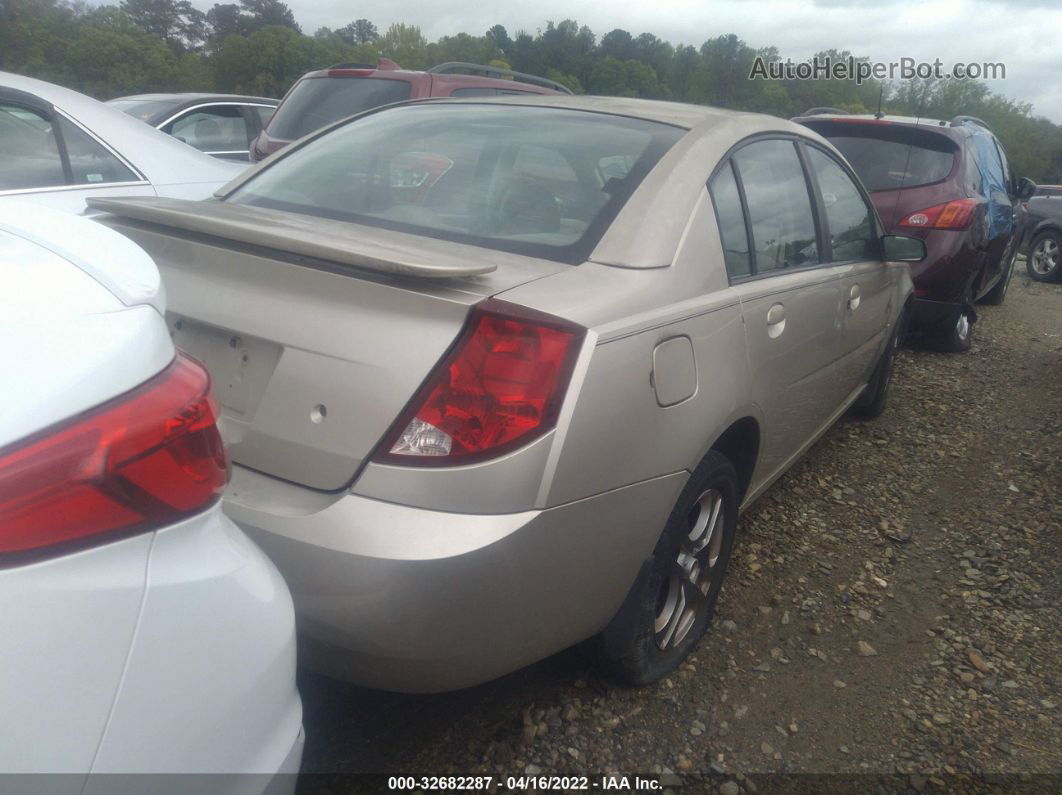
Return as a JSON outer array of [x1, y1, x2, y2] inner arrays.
[[0, 355, 228, 564]]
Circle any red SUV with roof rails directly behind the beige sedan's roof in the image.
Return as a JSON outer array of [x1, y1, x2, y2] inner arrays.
[[251, 58, 571, 161]]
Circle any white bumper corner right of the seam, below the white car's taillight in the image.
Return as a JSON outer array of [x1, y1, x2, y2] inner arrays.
[[85, 506, 303, 776]]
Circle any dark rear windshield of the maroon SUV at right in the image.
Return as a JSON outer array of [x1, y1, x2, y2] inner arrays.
[[808, 122, 958, 191]]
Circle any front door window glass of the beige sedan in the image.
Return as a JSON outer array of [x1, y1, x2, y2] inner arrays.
[[806, 146, 878, 262]]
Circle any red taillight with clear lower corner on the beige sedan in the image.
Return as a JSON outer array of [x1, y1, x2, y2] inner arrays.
[[376, 300, 586, 466]]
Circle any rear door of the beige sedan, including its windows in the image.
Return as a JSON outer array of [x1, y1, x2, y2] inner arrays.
[[709, 138, 844, 477]]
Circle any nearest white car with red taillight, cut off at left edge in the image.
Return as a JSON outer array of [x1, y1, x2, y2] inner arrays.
[[0, 204, 303, 792]]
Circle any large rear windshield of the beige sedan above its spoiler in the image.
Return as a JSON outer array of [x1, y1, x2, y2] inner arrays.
[[227, 103, 685, 262]]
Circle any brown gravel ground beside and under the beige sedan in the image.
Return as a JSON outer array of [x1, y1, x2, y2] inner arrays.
[[299, 269, 1062, 795]]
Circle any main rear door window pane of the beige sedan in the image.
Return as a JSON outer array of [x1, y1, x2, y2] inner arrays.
[[733, 139, 820, 274]]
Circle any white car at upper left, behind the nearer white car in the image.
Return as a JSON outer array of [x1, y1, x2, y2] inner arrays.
[[0, 72, 243, 212]]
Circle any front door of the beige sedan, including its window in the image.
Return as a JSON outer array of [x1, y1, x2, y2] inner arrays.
[[802, 144, 892, 392]]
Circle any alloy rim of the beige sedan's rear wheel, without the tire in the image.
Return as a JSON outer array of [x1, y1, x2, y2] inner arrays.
[[653, 488, 726, 651]]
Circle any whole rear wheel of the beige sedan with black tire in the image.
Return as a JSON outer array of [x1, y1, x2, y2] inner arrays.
[[602, 450, 739, 686]]
